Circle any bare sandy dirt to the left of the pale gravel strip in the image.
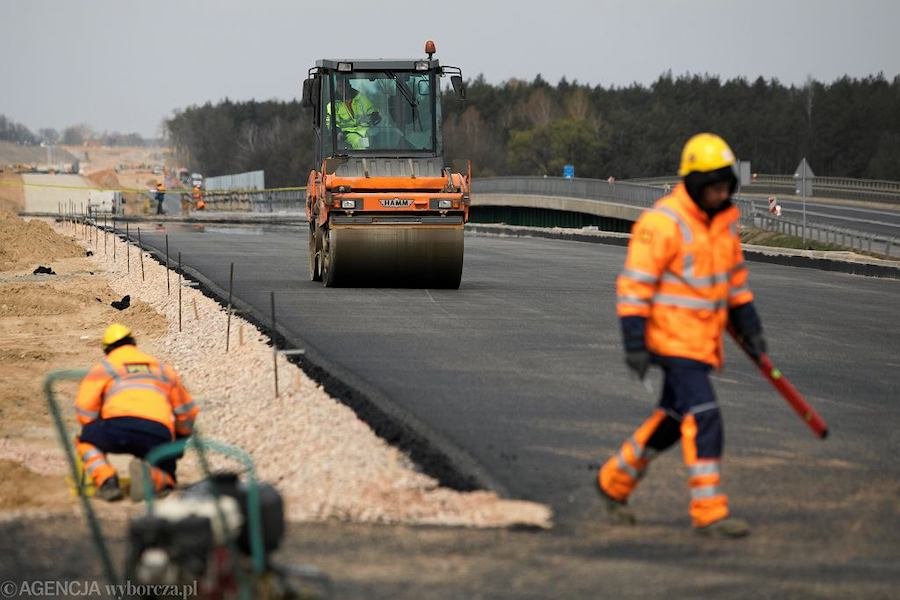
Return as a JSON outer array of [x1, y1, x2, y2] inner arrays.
[[0, 213, 165, 510]]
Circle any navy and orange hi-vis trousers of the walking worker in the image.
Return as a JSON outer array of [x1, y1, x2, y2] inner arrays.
[[597, 361, 728, 527]]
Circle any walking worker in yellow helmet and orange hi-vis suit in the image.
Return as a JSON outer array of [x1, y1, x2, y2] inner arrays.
[[597, 133, 765, 537]]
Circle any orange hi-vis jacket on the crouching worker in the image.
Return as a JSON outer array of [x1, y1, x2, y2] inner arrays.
[[75, 345, 200, 437]]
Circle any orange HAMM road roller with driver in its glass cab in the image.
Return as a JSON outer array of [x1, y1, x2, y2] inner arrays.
[[302, 41, 472, 289]]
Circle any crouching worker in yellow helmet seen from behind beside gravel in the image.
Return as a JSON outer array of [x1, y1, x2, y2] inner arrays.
[[75, 323, 200, 501]]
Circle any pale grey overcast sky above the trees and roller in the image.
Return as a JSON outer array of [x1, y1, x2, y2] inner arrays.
[[0, 0, 900, 137]]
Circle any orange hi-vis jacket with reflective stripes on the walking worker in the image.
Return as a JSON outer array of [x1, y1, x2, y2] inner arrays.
[[616, 184, 753, 368]]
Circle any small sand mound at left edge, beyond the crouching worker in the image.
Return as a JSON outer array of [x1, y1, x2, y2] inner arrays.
[[0, 211, 84, 271]]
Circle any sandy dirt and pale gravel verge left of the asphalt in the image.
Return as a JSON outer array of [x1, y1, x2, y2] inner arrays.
[[0, 212, 551, 527]]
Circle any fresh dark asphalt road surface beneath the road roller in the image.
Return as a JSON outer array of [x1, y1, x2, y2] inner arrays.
[[128, 224, 900, 534]]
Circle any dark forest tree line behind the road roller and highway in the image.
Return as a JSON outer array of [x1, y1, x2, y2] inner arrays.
[[165, 73, 900, 187]]
